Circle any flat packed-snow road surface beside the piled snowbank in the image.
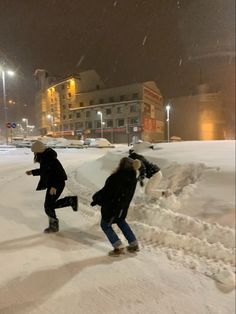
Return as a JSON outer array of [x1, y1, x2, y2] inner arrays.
[[0, 146, 235, 314]]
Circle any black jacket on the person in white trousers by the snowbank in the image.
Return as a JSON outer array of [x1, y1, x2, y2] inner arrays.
[[129, 153, 161, 181]]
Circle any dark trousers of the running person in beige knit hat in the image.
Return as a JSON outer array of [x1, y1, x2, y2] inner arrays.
[[44, 183, 71, 219]]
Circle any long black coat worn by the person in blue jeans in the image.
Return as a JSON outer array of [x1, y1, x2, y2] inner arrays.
[[91, 169, 137, 223]]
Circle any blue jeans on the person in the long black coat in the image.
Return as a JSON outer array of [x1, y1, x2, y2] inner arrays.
[[100, 219, 138, 248]]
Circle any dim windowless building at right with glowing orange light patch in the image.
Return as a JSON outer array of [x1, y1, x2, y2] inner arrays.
[[169, 84, 226, 141]]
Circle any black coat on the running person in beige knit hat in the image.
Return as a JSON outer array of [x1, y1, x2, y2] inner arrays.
[[32, 148, 67, 191]]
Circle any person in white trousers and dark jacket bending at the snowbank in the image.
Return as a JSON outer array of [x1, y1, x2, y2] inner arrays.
[[129, 147, 167, 198]]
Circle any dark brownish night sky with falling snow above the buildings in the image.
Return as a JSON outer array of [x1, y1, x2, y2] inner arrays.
[[0, 0, 235, 122]]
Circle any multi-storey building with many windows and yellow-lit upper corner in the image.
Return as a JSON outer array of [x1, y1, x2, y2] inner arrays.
[[35, 70, 164, 143]]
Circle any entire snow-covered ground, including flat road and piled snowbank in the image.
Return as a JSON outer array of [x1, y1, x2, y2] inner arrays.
[[0, 141, 235, 314]]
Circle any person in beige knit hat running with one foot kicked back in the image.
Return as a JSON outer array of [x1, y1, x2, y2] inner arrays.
[[26, 141, 78, 233]]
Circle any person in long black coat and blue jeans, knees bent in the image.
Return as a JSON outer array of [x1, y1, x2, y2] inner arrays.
[[91, 157, 140, 256]]
